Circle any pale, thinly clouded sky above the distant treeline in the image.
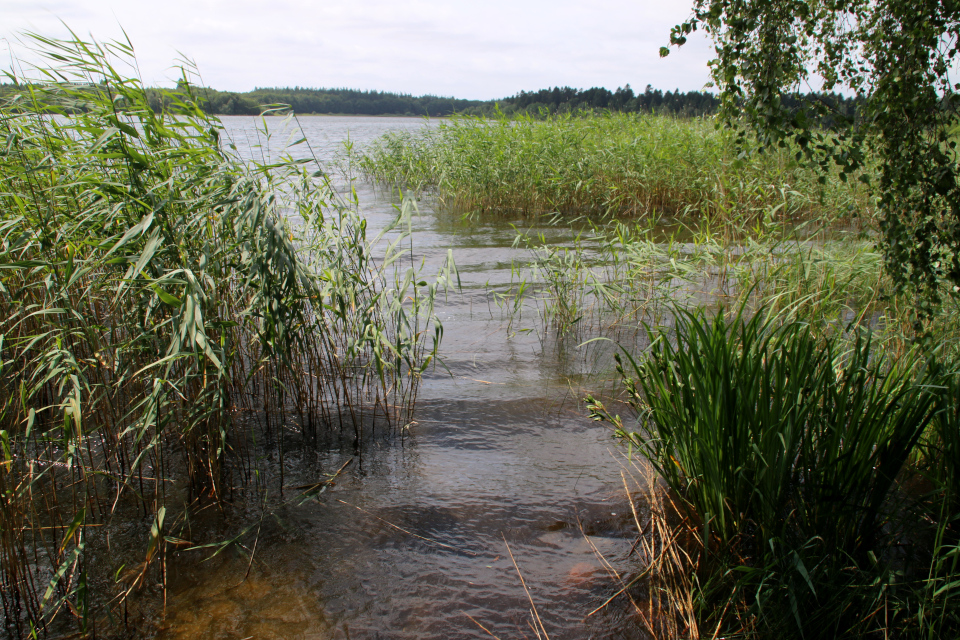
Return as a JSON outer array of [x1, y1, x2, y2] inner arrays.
[[0, 0, 713, 100]]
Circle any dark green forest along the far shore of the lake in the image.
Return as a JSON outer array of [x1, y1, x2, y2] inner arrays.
[[0, 84, 858, 122]]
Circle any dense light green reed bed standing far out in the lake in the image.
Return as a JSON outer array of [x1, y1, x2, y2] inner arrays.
[[356, 114, 871, 221]]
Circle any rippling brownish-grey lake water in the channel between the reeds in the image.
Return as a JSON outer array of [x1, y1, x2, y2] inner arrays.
[[159, 116, 639, 640]]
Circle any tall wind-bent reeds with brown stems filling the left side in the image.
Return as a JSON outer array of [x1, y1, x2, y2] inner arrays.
[[0, 36, 447, 638]]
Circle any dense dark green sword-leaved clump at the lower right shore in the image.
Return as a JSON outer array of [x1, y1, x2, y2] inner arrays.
[[591, 308, 960, 638]]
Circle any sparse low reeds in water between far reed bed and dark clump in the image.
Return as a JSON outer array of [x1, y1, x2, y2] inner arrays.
[[498, 220, 888, 349]]
